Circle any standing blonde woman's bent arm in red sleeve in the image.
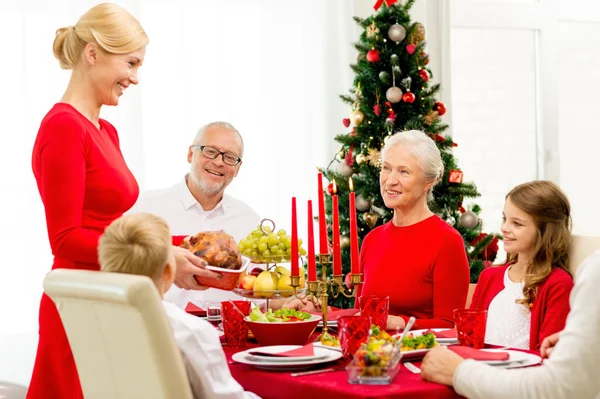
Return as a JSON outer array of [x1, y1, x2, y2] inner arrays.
[[36, 114, 100, 263]]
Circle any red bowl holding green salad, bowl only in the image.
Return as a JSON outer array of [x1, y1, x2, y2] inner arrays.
[[245, 315, 321, 346]]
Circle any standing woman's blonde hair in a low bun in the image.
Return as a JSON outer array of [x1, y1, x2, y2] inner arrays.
[[52, 3, 148, 69]]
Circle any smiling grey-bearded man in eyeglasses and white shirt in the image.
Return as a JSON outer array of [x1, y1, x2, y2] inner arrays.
[[129, 122, 260, 308]]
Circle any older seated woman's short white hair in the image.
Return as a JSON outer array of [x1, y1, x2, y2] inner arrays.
[[381, 130, 444, 202]]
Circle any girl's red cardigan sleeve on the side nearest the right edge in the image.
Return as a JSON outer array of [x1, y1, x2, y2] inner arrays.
[[531, 273, 573, 350]]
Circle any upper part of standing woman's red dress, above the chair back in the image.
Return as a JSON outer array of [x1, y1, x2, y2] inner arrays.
[[32, 103, 139, 270]]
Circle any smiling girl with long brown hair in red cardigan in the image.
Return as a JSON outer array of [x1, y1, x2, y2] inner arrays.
[[471, 181, 573, 350]]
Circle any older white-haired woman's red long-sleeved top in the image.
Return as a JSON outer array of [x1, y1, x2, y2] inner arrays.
[[360, 215, 469, 329]]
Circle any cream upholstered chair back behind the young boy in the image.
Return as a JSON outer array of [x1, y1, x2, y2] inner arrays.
[[44, 269, 192, 399]]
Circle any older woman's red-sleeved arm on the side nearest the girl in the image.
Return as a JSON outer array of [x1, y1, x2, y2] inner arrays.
[[400, 235, 469, 329]]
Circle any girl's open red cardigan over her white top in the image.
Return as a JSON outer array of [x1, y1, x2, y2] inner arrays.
[[471, 265, 573, 350]]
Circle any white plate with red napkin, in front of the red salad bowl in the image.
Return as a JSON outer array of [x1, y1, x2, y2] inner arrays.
[[231, 345, 342, 371]]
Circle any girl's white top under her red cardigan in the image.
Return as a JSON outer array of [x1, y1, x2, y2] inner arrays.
[[485, 266, 531, 349]]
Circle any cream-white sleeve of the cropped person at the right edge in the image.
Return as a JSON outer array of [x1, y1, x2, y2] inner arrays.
[[453, 251, 600, 399]]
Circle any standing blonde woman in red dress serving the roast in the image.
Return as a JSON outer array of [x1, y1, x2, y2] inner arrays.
[[27, 3, 215, 399]]
